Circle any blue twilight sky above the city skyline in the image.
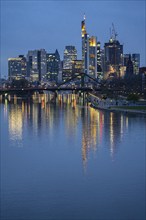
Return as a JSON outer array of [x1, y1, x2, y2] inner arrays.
[[1, 0, 146, 76]]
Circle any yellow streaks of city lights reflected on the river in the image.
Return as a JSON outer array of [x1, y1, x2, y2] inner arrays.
[[1, 93, 145, 166]]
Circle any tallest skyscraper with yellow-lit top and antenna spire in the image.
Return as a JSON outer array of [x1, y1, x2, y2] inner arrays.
[[81, 15, 89, 74]]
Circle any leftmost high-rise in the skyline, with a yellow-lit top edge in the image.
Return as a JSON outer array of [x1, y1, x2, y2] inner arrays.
[[8, 55, 26, 80]]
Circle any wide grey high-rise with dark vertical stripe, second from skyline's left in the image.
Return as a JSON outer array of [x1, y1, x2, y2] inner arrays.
[[27, 49, 47, 81]]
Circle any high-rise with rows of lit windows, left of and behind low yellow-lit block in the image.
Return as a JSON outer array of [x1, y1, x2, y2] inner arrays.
[[63, 46, 77, 69]]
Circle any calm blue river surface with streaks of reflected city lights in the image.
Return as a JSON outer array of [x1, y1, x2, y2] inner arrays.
[[0, 95, 146, 220]]
